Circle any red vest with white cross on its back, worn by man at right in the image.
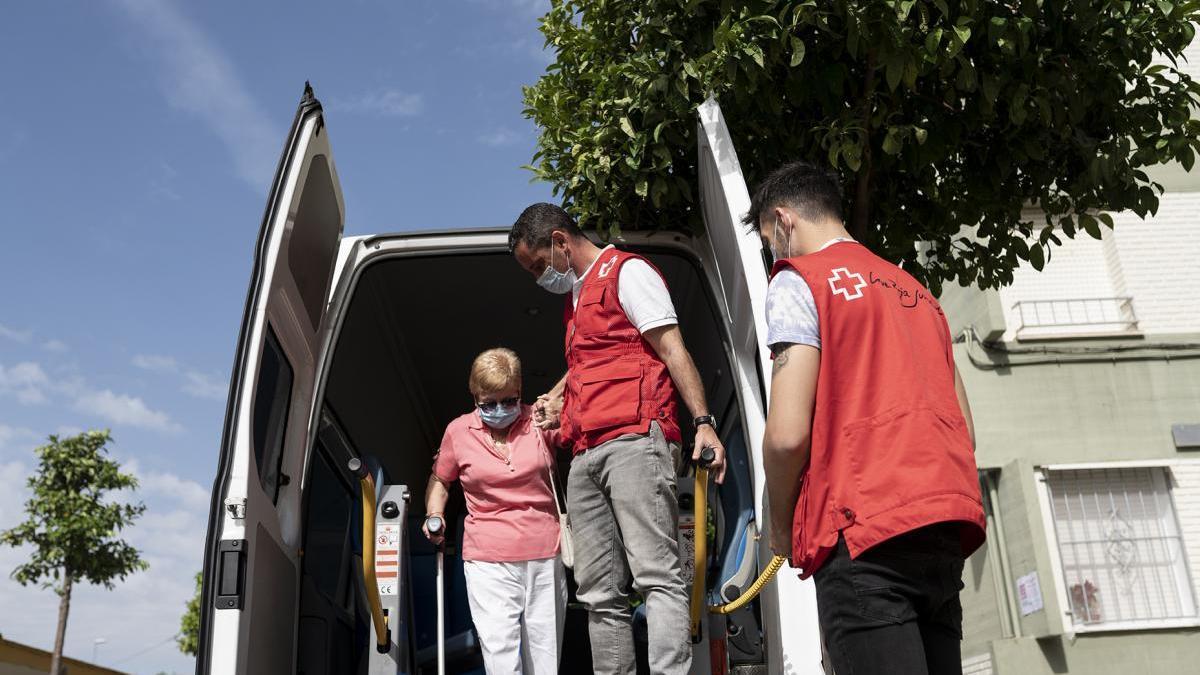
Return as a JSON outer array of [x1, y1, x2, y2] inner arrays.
[[772, 243, 985, 578]]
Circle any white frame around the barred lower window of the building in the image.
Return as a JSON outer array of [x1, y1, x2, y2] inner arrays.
[[1036, 460, 1200, 635]]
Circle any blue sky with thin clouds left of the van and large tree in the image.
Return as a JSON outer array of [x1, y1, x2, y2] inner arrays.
[[0, 0, 551, 673]]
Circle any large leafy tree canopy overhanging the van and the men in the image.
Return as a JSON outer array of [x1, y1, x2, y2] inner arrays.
[[524, 0, 1200, 288]]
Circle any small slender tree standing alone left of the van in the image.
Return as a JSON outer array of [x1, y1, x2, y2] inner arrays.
[[0, 431, 148, 675]]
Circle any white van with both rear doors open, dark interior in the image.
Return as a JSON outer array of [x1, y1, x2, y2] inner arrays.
[[197, 86, 822, 675]]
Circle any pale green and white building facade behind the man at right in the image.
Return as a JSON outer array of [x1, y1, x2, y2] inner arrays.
[[942, 40, 1200, 675]]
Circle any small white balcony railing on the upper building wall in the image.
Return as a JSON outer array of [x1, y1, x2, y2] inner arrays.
[[1013, 298, 1138, 338]]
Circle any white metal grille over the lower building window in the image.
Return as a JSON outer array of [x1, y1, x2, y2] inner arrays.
[[1048, 467, 1196, 627]]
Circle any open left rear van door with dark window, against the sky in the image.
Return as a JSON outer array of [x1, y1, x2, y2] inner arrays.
[[196, 84, 344, 675]]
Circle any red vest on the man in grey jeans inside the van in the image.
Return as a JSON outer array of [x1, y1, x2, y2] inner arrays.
[[560, 249, 680, 454]]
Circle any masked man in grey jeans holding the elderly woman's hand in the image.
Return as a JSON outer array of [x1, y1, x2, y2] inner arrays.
[[509, 204, 725, 675]]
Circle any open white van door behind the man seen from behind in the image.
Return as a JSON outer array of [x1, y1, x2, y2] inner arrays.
[[696, 98, 823, 674]]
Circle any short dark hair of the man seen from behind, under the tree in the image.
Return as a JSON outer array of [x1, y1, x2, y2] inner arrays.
[[742, 160, 841, 229]]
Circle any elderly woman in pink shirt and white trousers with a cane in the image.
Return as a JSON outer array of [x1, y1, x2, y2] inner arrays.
[[424, 348, 566, 675]]
